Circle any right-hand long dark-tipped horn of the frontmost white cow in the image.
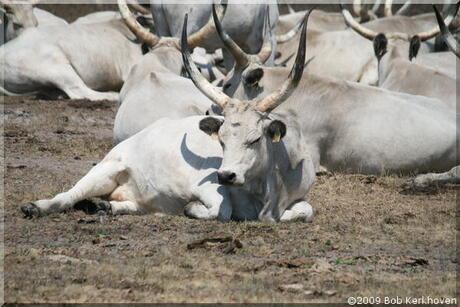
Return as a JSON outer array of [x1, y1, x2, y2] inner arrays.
[[250, 10, 312, 112]]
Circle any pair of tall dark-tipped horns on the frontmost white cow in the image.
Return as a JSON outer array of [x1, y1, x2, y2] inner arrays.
[[181, 8, 311, 112]]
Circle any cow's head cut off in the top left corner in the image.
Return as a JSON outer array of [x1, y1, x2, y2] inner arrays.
[[0, 0, 38, 39]]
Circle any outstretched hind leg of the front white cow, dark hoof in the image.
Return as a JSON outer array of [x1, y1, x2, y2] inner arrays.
[[21, 160, 125, 217]]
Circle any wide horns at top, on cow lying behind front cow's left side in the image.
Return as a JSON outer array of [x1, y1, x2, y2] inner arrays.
[[117, 0, 227, 48]]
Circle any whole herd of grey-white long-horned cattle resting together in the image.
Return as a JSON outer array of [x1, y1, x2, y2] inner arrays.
[[0, 0, 460, 221]]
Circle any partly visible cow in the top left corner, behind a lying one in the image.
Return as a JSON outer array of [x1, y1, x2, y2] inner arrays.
[[0, 0, 67, 43]]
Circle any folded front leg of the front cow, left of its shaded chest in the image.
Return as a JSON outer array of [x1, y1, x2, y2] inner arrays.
[[184, 183, 232, 221]]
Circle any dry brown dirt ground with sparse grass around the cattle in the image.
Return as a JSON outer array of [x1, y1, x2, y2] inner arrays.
[[3, 97, 459, 303]]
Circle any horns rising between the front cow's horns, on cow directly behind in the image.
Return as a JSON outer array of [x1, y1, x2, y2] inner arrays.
[[212, 4, 272, 67]]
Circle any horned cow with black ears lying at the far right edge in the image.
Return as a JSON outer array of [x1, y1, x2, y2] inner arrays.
[[342, 5, 458, 109]]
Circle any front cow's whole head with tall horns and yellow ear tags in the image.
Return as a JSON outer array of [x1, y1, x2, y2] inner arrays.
[[182, 10, 309, 185]]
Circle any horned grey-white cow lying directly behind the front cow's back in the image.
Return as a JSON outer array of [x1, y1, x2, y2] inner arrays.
[[113, 0, 224, 144]]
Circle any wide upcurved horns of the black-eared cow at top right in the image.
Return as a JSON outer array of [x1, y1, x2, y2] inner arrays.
[[340, 2, 460, 41]]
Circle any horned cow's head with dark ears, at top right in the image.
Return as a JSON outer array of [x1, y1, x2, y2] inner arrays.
[[340, 2, 460, 61]]
